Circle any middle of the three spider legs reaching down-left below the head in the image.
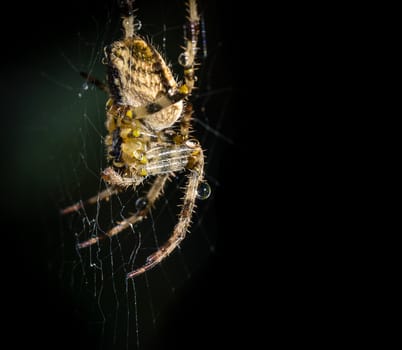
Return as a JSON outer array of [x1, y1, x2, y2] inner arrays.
[[78, 174, 169, 249]]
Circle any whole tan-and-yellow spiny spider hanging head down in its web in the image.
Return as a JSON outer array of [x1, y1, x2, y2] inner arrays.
[[61, 0, 210, 278]]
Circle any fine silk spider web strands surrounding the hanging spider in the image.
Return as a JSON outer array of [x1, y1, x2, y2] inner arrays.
[[42, 1, 232, 349]]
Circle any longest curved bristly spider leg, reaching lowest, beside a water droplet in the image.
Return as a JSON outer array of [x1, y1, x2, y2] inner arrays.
[[127, 148, 204, 278]]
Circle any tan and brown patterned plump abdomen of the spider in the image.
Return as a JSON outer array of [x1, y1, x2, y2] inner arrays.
[[106, 37, 183, 131]]
